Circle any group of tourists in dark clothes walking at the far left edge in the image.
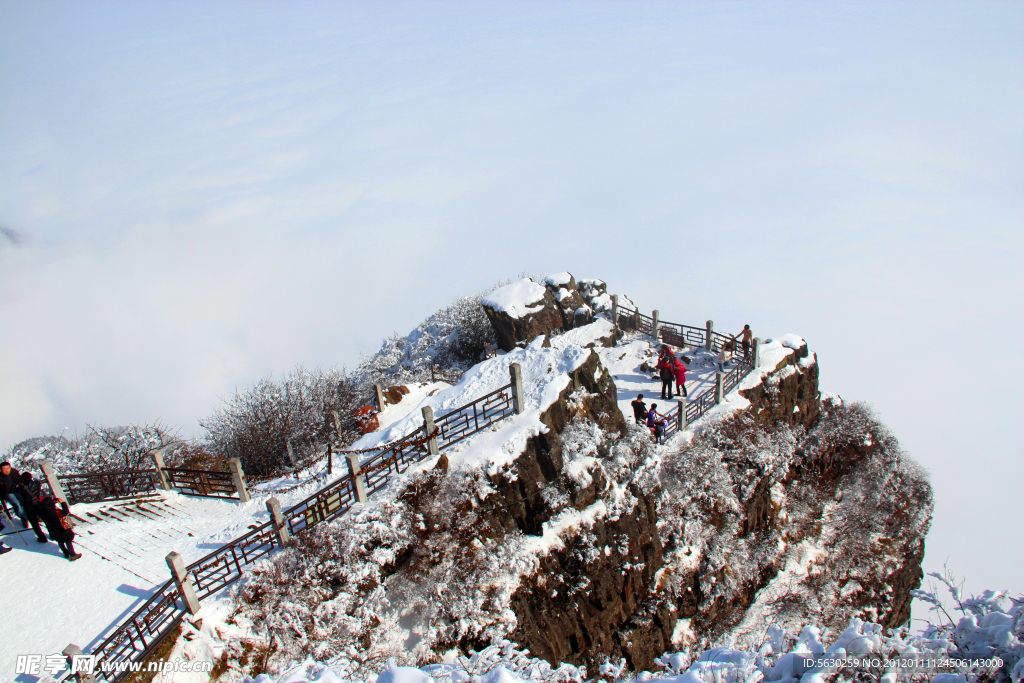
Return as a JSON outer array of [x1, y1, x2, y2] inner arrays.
[[0, 463, 82, 561]]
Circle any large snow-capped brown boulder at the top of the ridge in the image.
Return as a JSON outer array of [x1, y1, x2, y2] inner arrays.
[[480, 276, 571, 351]]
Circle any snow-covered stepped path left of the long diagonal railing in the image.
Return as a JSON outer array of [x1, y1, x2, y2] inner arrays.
[[0, 382, 450, 683]]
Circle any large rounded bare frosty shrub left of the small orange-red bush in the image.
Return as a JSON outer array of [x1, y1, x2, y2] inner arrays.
[[200, 366, 361, 476]]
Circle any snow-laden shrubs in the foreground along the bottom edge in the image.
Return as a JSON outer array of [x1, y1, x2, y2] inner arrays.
[[251, 574, 1024, 683]]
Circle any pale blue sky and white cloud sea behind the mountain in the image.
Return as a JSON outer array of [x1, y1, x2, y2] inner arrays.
[[0, 2, 1024, 614]]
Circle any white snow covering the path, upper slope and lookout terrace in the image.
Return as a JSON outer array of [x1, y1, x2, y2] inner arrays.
[[0, 319, 793, 683]]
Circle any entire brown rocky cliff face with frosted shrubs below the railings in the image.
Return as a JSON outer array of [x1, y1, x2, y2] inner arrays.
[[235, 329, 932, 674]]
